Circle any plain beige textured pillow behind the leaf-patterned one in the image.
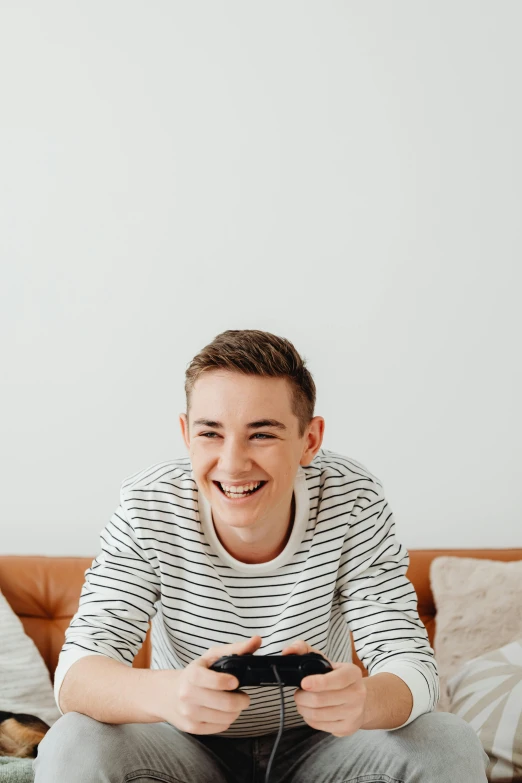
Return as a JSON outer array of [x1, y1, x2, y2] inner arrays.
[[430, 557, 522, 712]]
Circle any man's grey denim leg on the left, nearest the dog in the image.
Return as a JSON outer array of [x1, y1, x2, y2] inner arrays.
[[33, 712, 228, 783]]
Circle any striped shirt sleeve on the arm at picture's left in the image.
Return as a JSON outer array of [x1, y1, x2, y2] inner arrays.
[[54, 490, 161, 715]]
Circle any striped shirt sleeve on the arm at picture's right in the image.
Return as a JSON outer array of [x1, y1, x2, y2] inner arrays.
[[337, 480, 439, 731]]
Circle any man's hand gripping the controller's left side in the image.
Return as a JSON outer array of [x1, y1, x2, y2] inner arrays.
[[153, 636, 262, 734]]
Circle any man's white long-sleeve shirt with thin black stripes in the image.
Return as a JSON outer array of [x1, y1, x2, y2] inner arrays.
[[54, 449, 439, 736]]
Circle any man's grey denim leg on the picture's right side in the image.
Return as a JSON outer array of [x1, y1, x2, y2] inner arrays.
[[271, 712, 488, 783]]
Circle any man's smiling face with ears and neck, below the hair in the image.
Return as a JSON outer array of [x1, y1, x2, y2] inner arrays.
[[180, 370, 324, 562]]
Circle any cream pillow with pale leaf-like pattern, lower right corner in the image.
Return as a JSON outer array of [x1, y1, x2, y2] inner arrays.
[[442, 639, 522, 783]]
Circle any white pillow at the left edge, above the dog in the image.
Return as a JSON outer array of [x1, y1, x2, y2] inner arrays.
[[0, 591, 61, 726]]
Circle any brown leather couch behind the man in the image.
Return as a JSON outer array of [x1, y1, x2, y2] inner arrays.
[[0, 549, 522, 680]]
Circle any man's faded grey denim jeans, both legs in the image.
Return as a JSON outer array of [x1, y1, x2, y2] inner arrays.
[[33, 712, 488, 783]]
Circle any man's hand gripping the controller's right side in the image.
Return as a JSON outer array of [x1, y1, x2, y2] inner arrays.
[[282, 639, 367, 737]]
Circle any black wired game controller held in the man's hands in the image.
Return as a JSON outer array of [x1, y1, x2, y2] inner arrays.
[[209, 653, 332, 690]]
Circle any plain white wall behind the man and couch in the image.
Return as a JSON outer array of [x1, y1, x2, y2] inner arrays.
[[0, 0, 522, 556]]
